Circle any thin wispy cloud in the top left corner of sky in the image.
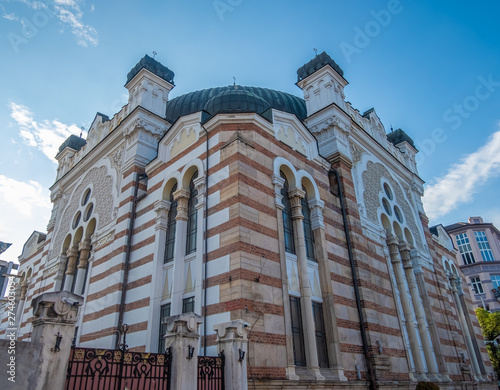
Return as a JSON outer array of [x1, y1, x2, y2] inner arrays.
[[0, 0, 99, 47]]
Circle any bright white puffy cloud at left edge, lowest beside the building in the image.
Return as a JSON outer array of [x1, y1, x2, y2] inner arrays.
[[0, 175, 52, 261]]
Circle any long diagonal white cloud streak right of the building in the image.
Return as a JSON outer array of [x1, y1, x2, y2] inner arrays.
[[423, 131, 500, 219]]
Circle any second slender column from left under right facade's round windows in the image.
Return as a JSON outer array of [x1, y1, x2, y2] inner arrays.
[[399, 242, 439, 379]]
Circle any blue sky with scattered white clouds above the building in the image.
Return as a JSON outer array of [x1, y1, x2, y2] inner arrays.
[[0, 0, 500, 260]]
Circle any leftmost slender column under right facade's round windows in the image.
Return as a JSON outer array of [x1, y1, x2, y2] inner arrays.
[[387, 235, 425, 376]]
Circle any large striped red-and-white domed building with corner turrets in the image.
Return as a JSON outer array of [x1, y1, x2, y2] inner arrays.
[[0, 53, 493, 389]]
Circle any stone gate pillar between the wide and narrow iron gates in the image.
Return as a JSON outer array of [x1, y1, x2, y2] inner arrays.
[[165, 313, 203, 390]]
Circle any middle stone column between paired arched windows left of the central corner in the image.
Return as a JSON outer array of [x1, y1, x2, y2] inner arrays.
[[172, 188, 189, 314]]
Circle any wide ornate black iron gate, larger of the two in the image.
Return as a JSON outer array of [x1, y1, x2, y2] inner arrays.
[[65, 347, 172, 390]]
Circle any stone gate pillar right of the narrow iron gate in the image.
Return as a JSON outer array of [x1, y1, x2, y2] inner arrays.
[[214, 320, 248, 390]]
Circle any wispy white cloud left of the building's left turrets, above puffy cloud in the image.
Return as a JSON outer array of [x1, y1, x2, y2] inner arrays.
[[9, 102, 80, 162]]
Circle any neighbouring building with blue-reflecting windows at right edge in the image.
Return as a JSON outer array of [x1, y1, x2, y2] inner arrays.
[[445, 217, 500, 311]]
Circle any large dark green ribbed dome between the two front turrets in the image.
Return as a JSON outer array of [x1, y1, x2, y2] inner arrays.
[[165, 85, 307, 123]]
